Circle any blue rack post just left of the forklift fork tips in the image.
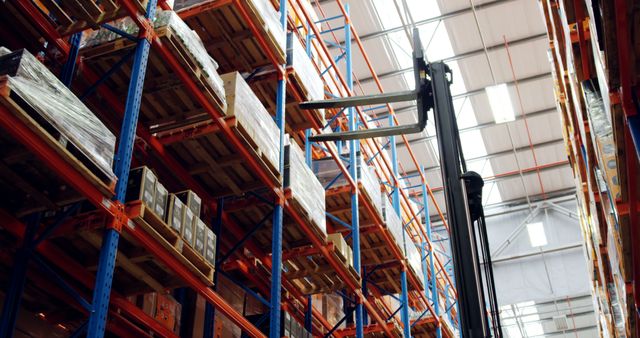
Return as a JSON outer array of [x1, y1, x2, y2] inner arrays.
[[269, 1, 288, 338]]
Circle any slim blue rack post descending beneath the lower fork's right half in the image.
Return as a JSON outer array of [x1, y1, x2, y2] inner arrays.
[[389, 114, 414, 338]]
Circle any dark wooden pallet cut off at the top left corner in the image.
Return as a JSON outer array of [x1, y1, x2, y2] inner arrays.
[[34, 0, 148, 35]]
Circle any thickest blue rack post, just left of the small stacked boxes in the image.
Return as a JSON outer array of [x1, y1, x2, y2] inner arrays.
[[87, 0, 157, 338]]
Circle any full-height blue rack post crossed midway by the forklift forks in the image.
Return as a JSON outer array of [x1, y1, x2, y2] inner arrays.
[[344, 4, 362, 338]]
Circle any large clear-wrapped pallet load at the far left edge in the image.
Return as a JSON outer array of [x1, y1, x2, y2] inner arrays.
[[0, 47, 116, 180]]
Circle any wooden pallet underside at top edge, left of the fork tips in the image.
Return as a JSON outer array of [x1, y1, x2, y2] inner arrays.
[[178, 1, 286, 73]]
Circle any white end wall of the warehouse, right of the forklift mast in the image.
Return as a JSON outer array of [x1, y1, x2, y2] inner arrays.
[[487, 201, 590, 304]]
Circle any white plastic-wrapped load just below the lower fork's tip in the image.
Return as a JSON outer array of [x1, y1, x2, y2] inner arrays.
[[284, 139, 327, 234]]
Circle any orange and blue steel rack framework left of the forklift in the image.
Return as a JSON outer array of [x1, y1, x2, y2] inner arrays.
[[0, 0, 457, 337]]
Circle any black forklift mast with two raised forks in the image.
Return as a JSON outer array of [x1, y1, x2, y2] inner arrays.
[[300, 29, 502, 338]]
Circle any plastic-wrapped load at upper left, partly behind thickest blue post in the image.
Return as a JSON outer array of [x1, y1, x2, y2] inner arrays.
[[81, 11, 226, 110]]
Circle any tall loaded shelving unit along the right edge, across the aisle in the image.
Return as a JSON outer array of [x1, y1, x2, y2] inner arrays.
[[541, 0, 640, 337]]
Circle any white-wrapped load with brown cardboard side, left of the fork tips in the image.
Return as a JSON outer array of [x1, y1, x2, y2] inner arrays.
[[221, 72, 280, 172]]
